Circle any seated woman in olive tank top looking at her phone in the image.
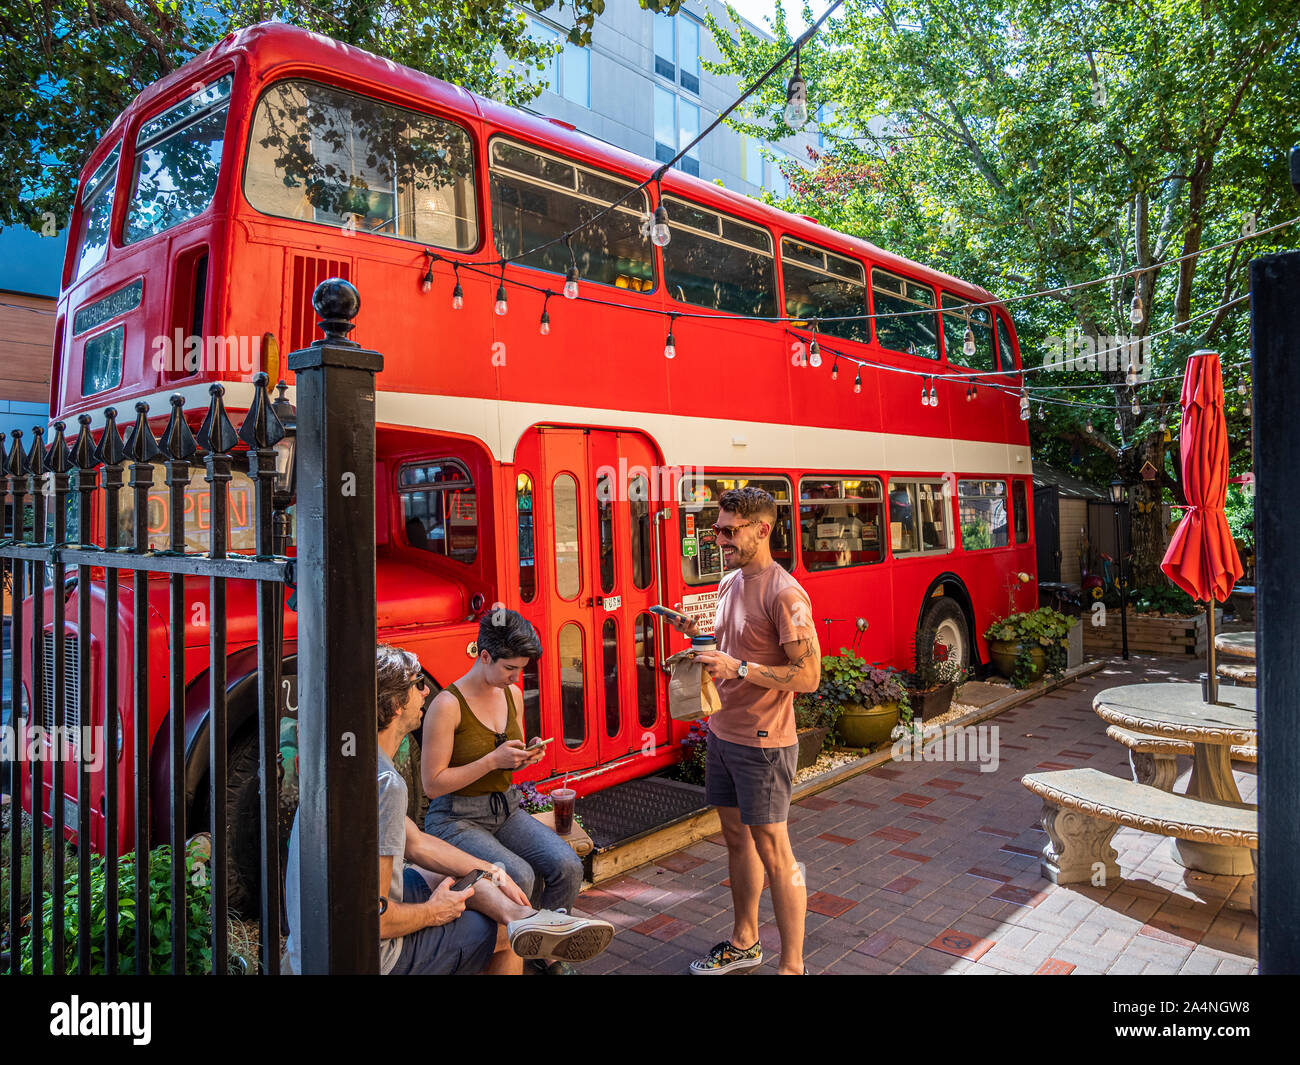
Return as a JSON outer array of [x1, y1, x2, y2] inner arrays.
[[420, 609, 582, 972]]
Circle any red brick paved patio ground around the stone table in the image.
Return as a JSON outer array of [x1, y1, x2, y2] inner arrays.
[[577, 655, 1257, 974]]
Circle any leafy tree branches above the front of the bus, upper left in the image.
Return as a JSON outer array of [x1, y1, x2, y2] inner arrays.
[[0, 0, 681, 229]]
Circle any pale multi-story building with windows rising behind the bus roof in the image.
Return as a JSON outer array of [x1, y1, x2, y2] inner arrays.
[[504, 0, 820, 195]]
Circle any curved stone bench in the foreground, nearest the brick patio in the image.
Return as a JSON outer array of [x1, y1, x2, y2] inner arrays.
[[1021, 769, 1260, 913]]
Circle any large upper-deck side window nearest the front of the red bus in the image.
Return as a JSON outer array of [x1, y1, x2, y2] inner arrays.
[[243, 81, 478, 251]]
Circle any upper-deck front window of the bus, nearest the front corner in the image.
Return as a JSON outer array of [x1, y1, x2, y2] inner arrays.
[[122, 74, 234, 244]]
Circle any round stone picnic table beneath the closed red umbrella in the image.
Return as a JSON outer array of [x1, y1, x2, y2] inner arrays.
[[1092, 683, 1257, 876]]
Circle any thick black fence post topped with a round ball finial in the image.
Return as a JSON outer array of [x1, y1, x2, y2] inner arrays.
[[289, 278, 384, 973]]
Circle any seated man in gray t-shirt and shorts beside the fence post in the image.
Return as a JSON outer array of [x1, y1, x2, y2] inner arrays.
[[285, 645, 614, 975]]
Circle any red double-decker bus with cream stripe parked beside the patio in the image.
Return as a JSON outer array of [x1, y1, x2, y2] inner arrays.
[[29, 25, 1035, 894]]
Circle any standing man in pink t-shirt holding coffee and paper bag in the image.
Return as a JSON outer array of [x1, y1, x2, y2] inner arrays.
[[677, 488, 822, 975]]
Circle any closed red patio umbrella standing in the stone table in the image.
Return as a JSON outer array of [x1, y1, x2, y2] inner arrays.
[[1160, 351, 1243, 702]]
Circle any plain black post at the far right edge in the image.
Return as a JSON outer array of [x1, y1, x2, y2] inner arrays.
[[1251, 251, 1300, 974]]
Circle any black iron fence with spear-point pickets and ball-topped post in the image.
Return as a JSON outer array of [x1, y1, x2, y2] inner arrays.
[[0, 280, 382, 974]]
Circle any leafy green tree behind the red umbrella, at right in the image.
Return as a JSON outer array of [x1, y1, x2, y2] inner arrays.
[[710, 0, 1300, 584]]
